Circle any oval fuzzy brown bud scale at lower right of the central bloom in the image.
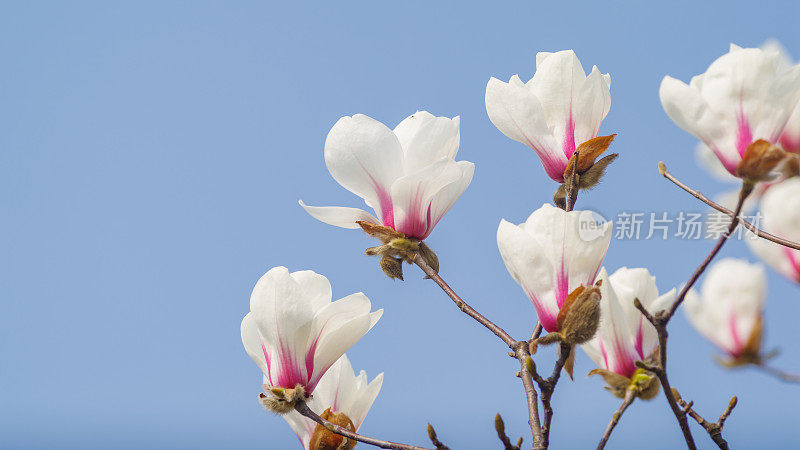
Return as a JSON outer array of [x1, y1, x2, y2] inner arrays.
[[556, 286, 600, 345]]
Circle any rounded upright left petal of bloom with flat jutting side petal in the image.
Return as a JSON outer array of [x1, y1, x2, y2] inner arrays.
[[325, 114, 403, 226]]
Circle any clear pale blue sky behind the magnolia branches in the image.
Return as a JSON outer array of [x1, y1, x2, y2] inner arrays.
[[0, 1, 800, 449]]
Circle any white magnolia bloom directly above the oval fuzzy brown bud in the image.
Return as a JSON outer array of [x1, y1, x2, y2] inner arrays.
[[497, 204, 612, 332]]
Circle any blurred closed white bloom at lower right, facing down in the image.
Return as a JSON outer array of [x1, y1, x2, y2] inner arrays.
[[684, 258, 767, 358]]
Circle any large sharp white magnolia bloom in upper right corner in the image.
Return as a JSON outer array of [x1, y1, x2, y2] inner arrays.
[[659, 44, 800, 174]]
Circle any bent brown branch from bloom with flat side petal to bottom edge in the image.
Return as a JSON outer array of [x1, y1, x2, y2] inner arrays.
[[414, 254, 542, 443]]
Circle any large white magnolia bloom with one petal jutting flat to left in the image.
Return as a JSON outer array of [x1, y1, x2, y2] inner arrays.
[[300, 111, 475, 240]]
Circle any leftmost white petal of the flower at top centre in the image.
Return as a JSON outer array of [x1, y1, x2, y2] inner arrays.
[[486, 75, 567, 182]]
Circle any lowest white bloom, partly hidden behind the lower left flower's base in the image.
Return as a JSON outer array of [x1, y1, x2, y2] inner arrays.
[[281, 355, 383, 450]]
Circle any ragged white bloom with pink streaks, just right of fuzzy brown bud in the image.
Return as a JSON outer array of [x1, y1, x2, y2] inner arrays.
[[581, 267, 675, 378]]
